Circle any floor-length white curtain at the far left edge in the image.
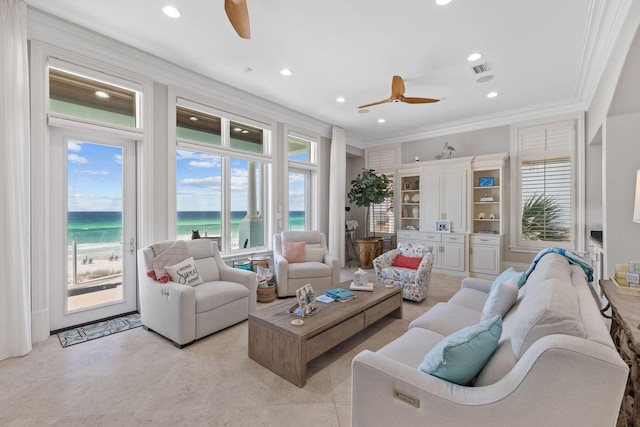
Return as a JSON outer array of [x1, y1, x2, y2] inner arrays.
[[0, 0, 31, 360]]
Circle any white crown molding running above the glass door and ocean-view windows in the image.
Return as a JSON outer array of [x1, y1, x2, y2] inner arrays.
[[27, 6, 332, 138]]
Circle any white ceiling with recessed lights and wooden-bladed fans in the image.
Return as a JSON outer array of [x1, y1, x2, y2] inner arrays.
[[27, 0, 617, 144]]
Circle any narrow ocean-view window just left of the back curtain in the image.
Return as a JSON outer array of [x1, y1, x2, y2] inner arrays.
[[287, 133, 318, 230]]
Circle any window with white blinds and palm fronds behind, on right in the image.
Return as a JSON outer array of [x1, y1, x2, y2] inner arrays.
[[512, 120, 576, 250]]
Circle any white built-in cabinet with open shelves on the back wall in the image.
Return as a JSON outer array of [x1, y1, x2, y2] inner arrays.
[[397, 153, 507, 278]]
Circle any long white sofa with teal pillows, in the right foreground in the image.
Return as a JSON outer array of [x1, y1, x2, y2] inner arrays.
[[352, 254, 628, 427]]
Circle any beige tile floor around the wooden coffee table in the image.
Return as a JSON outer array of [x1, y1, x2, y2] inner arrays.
[[0, 268, 461, 427]]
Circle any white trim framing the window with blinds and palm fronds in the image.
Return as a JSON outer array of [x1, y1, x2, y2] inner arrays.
[[509, 112, 586, 253]]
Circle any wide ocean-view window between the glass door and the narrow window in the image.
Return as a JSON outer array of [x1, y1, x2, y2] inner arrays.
[[176, 101, 271, 252]]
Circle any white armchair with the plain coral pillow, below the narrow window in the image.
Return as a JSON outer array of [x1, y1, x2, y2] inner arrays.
[[273, 231, 340, 297]]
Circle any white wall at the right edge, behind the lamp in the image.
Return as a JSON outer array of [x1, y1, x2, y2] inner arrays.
[[602, 113, 640, 277]]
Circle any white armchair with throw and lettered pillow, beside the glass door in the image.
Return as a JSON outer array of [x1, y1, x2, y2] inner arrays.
[[138, 239, 257, 347]]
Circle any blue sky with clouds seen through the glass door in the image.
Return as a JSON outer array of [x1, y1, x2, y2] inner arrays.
[[67, 140, 122, 212]]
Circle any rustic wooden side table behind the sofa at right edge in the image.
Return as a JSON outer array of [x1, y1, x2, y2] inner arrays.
[[600, 280, 640, 427]]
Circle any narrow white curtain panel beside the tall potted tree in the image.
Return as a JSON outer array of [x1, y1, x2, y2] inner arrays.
[[328, 126, 347, 267]]
